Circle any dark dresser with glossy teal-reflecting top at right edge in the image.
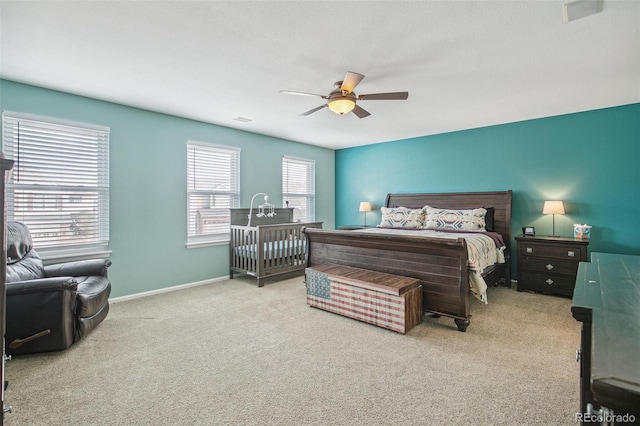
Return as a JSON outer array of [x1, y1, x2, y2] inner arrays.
[[571, 253, 640, 424]]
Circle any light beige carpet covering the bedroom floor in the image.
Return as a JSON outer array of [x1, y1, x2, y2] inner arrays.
[[5, 278, 580, 425]]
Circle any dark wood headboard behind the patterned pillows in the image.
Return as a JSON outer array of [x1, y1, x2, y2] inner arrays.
[[385, 190, 512, 253]]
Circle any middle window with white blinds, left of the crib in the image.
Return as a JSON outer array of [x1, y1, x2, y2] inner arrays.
[[187, 141, 240, 246]]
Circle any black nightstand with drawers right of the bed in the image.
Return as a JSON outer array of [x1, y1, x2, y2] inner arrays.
[[516, 235, 589, 297]]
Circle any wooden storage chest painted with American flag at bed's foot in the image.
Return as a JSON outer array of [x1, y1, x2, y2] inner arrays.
[[305, 264, 422, 334]]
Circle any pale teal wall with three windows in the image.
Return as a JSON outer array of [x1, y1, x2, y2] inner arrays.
[[0, 80, 335, 297]]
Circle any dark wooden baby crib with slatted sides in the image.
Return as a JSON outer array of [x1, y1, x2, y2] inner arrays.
[[229, 208, 322, 287]]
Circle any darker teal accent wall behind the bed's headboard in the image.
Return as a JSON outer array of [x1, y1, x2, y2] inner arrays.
[[336, 104, 640, 267]]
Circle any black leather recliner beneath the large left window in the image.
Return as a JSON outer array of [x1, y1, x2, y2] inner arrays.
[[5, 222, 111, 354]]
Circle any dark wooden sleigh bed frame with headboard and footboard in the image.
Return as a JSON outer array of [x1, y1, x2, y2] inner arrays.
[[305, 191, 512, 331]]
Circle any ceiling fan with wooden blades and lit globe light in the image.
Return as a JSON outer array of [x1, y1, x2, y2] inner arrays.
[[280, 71, 409, 118]]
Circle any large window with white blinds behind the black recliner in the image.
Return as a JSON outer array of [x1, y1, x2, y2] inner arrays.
[[2, 112, 110, 257]]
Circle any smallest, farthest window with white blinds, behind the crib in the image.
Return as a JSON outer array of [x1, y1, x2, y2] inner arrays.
[[282, 156, 316, 222]]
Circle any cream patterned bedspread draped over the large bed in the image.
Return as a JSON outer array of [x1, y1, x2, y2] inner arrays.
[[358, 228, 505, 303]]
